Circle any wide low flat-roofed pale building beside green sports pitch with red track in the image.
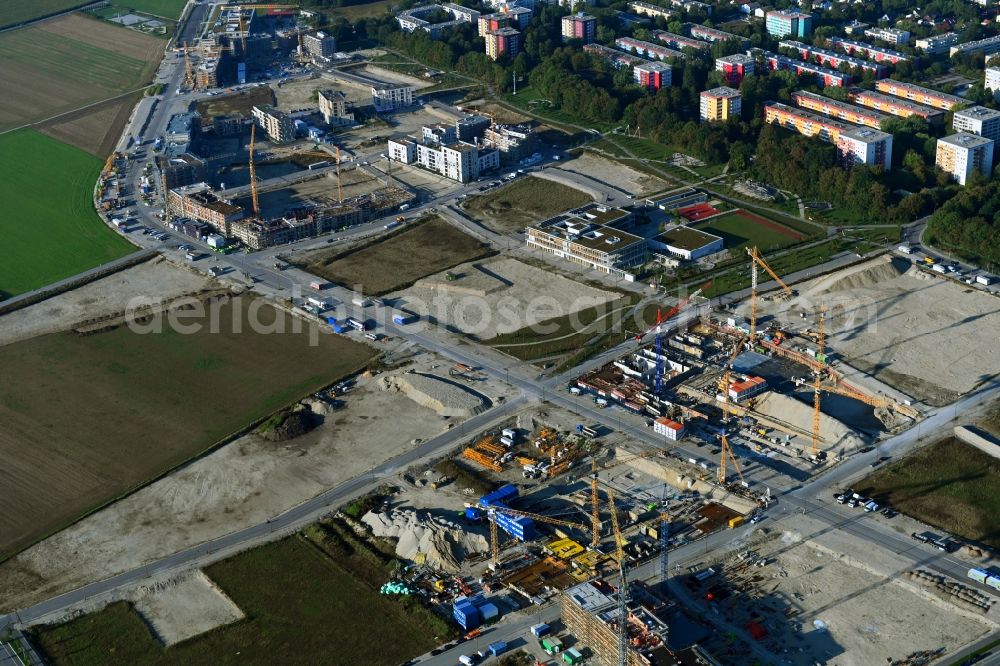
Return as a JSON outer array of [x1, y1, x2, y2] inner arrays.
[[527, 204, 647, 277]]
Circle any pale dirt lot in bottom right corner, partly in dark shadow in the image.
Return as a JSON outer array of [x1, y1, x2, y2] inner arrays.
[[702, 516, 993, 666]]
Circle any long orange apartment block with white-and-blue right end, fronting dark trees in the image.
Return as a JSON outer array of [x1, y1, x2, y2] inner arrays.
[[764, 102, 892, 170]]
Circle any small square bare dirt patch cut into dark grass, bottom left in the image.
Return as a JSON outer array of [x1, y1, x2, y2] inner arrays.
[[135, 571, 244, 645]]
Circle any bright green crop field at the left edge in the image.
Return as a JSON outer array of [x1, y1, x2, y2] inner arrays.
[[0, 130, 136, 296]]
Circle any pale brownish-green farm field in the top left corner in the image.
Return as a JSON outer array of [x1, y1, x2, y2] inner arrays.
[[0, 14, 164, 131]]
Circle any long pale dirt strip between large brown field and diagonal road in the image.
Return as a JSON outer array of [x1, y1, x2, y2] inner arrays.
[[0, 354, 505, 608]]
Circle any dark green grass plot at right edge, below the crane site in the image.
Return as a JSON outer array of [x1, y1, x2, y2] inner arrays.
[[857, 437, 1000, 548]]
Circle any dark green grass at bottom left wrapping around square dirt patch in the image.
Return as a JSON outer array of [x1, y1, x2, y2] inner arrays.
[[35, 526, 447, 666]]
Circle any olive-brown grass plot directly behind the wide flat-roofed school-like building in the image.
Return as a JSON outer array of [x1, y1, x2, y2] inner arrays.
[[464, 176, 593, 233]]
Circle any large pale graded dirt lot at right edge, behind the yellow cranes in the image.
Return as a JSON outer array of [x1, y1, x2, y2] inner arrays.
[[748, 257, 1000, 406]]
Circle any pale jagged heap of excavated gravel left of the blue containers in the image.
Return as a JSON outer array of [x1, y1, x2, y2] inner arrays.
[[361, 509, 489, 571]]
